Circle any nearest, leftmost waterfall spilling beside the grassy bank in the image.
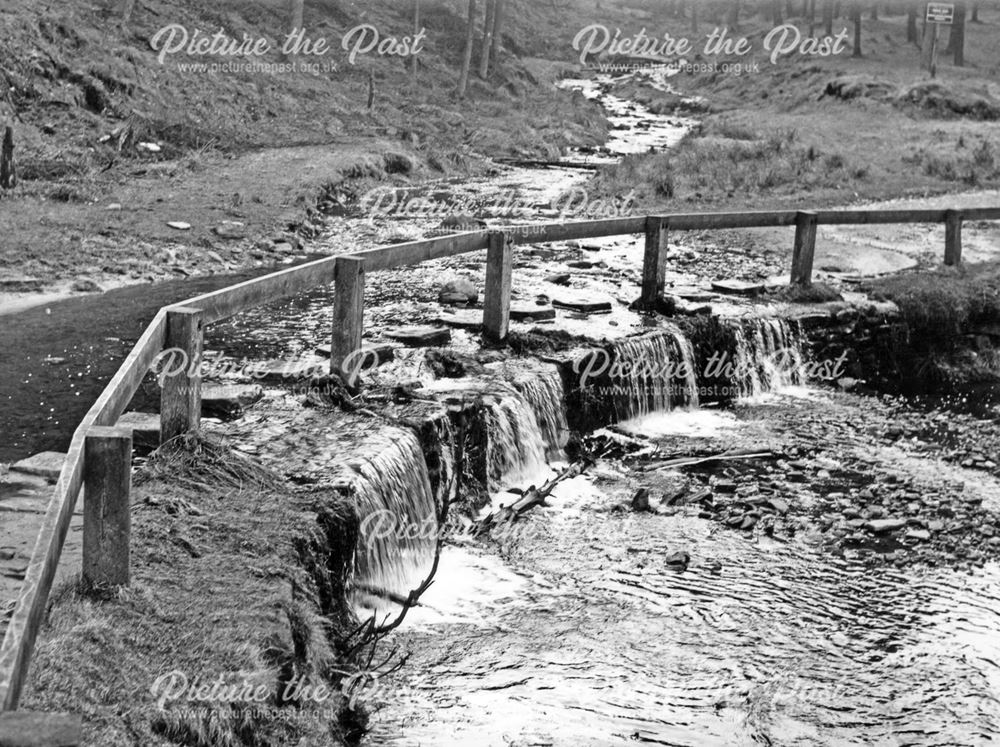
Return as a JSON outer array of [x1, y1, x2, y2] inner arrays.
[[335, 427, 438, 596]]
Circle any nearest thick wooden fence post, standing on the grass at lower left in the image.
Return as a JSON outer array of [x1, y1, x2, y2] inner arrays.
[[83, 427, 132, 589]]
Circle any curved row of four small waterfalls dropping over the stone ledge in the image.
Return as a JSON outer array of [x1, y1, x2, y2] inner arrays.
[[349, 318, 804, 596]]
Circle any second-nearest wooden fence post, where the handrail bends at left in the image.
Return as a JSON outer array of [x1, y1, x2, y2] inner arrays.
[[160, 308, 204, 444]]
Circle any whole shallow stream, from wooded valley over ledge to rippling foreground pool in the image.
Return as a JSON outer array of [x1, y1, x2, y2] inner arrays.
[[0, 73, 1000, 745]]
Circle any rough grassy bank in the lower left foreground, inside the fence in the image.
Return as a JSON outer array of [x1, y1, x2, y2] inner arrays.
[[21, 439, 366, 747]]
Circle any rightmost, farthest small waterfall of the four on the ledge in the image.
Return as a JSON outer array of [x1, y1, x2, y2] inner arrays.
[[733, 319, 804, 397]]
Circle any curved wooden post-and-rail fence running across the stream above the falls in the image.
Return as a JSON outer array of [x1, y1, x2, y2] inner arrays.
[[0, 207, 1000, 723]]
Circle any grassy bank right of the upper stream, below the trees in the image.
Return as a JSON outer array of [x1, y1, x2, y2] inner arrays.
[[597, 8, 1000, 208]]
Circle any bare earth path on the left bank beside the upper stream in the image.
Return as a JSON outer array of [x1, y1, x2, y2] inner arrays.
[[0, 138, 426, 314]]
